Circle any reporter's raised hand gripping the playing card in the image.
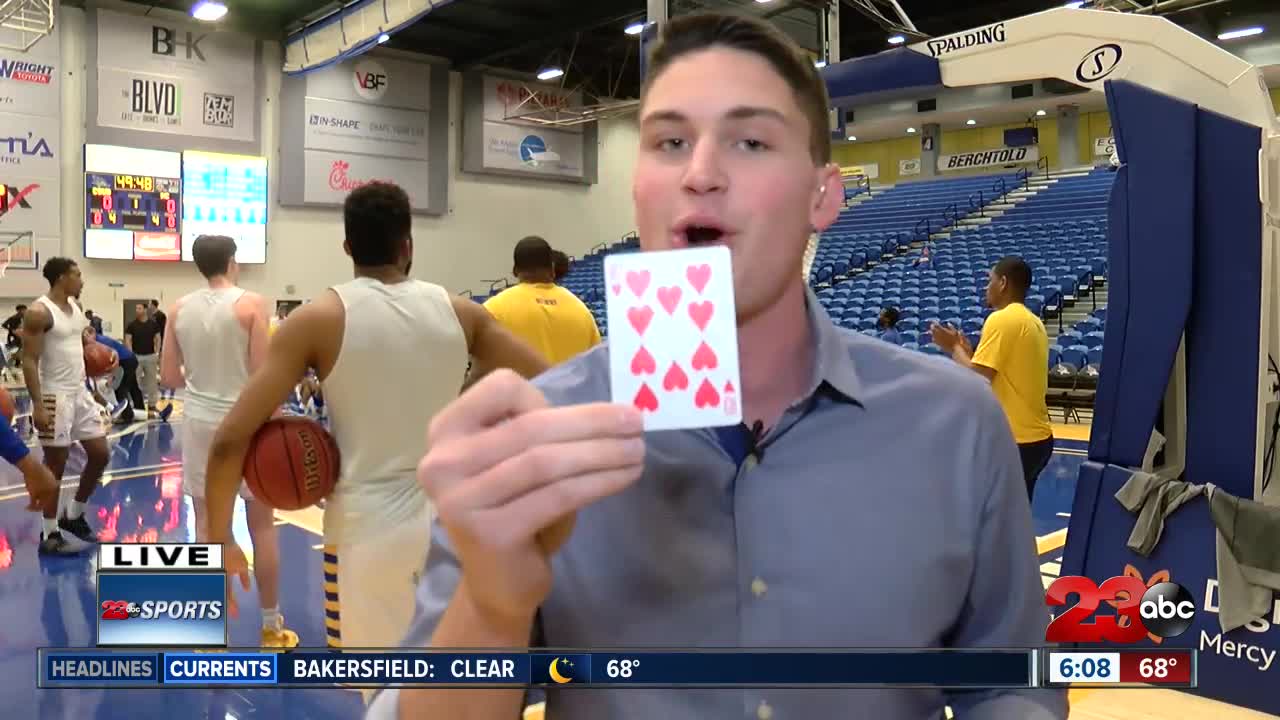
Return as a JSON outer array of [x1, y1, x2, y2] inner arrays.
[[417, 370, 644, 623]]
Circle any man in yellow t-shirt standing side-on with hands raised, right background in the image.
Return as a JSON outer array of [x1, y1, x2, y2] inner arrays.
[[932, 256, 1053, 498]]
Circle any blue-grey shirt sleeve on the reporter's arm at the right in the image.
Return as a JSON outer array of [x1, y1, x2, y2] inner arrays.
[[946, 395, 1068, 720]]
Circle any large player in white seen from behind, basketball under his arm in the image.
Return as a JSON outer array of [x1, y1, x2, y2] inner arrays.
[[207, 183, 547, 671]]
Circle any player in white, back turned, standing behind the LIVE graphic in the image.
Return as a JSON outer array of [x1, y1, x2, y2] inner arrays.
[[160, 234, 298, 647]]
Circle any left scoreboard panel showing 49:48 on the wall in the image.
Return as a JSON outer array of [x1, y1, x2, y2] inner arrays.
[[84, 145, 182, 261]]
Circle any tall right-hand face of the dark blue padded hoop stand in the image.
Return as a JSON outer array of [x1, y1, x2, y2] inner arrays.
[[1187, 109, 1262, 498]]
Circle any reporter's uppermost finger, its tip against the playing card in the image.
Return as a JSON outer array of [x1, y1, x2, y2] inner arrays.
[[421, 402, 644, 483]]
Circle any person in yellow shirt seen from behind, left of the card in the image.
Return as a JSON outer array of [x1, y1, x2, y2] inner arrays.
[[484, 236, 600, 365]]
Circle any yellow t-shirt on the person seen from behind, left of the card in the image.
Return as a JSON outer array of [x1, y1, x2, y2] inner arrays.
[[484, 283, 600, 365]]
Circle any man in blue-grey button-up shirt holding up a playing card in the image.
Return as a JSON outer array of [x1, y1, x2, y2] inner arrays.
[[358, 15, 1066, 720]]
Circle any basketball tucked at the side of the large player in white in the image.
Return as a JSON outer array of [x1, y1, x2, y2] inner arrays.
[[244, 416, 340, 510]]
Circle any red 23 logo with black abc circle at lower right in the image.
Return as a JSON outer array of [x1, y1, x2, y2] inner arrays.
[[1044, 575, 1196, 643]]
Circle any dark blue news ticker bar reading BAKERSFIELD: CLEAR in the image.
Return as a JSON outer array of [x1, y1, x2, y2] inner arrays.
[[37, 648, 1196, 689]]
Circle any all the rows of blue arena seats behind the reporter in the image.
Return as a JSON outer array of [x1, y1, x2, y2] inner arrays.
[[474, 170, 1115, 371]]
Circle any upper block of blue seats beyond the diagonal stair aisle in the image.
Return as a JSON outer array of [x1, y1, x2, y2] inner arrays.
[[809, 174, 1019, 287]]
